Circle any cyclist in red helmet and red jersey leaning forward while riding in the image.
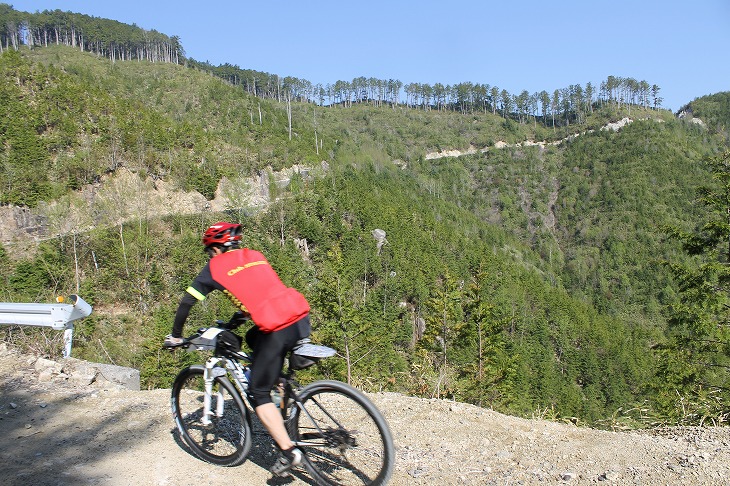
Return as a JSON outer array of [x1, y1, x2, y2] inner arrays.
[[164, 222, 311, 476]]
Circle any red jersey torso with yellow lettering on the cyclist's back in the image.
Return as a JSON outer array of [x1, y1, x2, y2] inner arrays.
[[210, 248, 309, 332]]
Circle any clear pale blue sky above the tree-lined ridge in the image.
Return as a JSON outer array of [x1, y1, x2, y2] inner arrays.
[[7, 0, 730, 111]]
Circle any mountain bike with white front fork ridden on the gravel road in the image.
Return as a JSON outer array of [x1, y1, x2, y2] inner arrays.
[[166, 315, 395, 485]]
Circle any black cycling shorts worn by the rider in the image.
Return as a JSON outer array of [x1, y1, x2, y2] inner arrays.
[[246, 315, 312, 407]]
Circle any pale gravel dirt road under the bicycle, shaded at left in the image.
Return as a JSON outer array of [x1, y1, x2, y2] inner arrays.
[[0, 345, 730, 486]]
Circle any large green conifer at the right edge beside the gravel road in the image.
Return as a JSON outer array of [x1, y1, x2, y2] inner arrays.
[[657, 151, 730, 423]]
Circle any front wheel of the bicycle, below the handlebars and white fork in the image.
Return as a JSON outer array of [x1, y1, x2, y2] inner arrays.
[[171, 365, 251, 466]]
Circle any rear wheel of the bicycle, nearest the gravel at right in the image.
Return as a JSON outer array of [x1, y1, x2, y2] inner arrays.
[[287, 380, 395, 486]]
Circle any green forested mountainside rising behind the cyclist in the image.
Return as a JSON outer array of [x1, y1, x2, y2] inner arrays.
[[0, 6, 730, 428]]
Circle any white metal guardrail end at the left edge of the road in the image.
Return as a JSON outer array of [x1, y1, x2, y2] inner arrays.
[[0, 294, 92, 358]]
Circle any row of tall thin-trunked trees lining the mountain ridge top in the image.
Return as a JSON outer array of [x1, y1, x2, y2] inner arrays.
[[0, 4, 663, 121]]
